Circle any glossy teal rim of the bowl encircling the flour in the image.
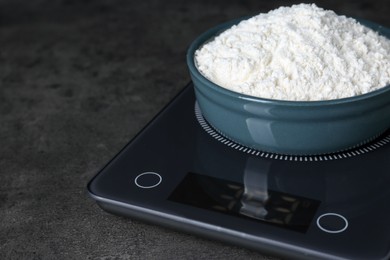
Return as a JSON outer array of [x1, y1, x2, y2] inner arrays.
[[186, 16, 390, 107]]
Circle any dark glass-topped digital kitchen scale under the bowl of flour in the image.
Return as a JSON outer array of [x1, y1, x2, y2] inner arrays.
[[88, 83, 390, 260]]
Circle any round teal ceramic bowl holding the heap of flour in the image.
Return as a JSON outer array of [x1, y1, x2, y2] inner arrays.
[[187, 19, 390, 155]]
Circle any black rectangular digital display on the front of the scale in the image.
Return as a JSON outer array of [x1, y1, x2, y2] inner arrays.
[[168, 173, 320, 233]]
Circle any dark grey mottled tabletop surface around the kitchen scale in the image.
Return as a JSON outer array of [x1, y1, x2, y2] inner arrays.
[[0, 0, 390, 259]]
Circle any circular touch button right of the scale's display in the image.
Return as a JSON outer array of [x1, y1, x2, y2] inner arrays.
[[317, 213, 348, 234]]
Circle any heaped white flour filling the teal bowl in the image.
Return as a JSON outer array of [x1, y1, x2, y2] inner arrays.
[[195, 4, 390, 101]]
